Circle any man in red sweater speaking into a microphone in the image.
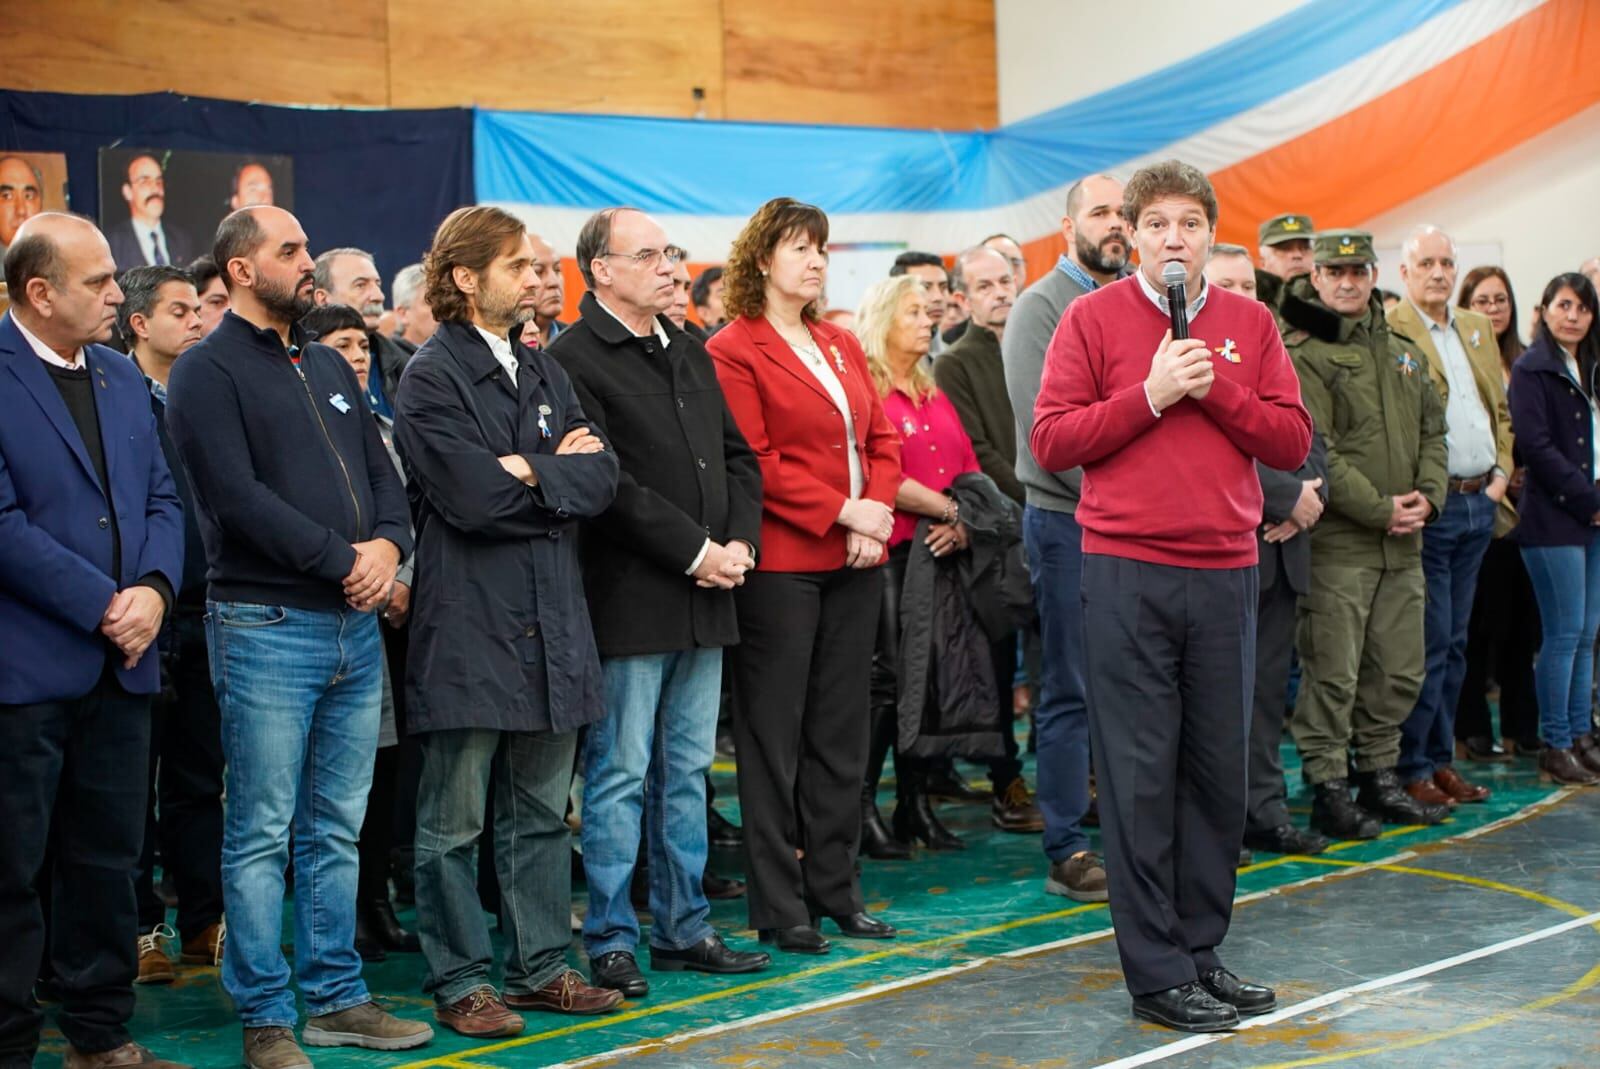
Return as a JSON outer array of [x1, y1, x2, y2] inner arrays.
[[1032, 160, 1312, 1032]]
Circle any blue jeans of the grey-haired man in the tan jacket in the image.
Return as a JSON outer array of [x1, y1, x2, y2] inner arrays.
[[1398, 493, 1494, 783]]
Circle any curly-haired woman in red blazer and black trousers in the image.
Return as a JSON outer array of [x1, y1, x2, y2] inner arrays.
[[706, 197, 899, 954]]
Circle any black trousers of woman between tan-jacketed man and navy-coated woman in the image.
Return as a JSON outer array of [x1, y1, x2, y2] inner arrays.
[[1456, 538, 1542, 741]]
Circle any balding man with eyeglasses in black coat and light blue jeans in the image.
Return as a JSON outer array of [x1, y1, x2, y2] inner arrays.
[[550, 208, 771, 999]]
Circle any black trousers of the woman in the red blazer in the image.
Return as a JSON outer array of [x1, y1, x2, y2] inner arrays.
[[733, 568, 883, 928]]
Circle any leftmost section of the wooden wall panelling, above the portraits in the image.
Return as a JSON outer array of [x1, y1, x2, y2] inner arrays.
[[0, 0, 389, 107]]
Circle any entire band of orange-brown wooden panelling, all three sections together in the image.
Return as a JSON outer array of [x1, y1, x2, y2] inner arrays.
[[0, 0, 997, 130]]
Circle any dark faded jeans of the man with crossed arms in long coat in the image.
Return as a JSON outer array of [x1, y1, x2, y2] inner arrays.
[[416, 728, 579, 1005]]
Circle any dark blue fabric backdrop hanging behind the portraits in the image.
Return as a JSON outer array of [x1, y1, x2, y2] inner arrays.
[[0, 90, 475, 283]]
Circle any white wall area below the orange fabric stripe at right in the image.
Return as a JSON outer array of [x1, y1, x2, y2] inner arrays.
[[1365, 104, 1600, 315]]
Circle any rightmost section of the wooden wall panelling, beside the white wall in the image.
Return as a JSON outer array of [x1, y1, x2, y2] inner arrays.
[[723, 0, 997, 130]]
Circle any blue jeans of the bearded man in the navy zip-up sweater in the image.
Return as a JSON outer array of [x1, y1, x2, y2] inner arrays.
[[206, 602, 382, 1027]]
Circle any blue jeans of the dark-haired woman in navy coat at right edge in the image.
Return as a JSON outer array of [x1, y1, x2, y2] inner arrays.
[[1522, 535, 1600, 751]]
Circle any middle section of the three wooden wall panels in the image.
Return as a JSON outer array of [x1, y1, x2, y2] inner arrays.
[[389, 0, 722, 118]]
